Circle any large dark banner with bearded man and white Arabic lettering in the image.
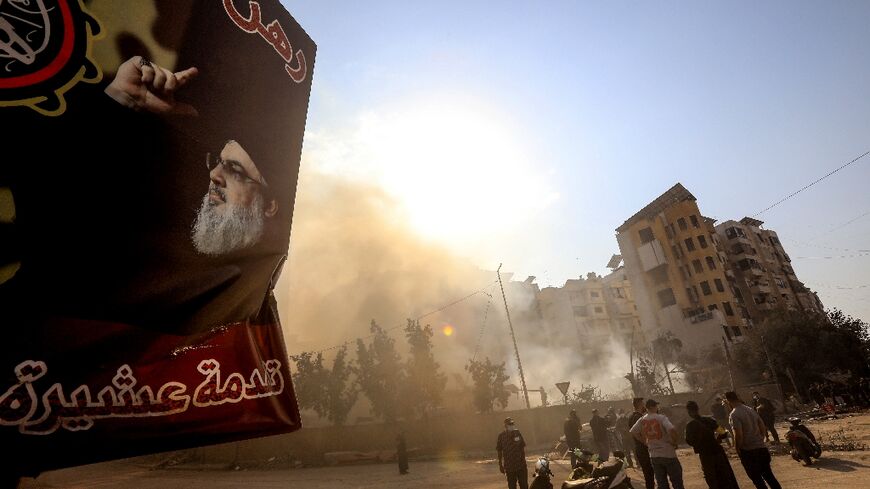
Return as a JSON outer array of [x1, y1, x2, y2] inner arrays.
[[0, 0, 316, 473]]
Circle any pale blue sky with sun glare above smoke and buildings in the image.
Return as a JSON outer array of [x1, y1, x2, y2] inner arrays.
[[282, 0, 870, 320]]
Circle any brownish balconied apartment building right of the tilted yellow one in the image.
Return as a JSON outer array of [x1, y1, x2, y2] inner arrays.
[[716, 217, 824, 322]]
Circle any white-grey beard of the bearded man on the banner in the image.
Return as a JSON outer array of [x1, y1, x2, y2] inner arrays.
[[191, 190, 264, 255]]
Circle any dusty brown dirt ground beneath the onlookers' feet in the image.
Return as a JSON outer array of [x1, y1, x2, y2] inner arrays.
[[21, 414, 870, 489]]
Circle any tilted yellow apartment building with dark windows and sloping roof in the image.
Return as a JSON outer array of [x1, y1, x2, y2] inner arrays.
[[616, 183, 747, 348]]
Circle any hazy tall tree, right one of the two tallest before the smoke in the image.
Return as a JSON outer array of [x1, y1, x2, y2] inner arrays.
[[403, 319, 447, 416]]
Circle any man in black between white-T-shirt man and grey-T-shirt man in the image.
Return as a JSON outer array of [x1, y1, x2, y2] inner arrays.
[[686, 401, 740, 489]]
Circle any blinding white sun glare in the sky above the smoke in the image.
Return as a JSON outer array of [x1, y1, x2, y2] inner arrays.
[[344, 99, 556, 243]]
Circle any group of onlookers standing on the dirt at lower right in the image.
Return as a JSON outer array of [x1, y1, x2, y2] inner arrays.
[[496, 392, 796, 489]]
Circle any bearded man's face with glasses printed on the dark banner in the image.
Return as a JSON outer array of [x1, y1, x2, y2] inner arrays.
[[192, 140, 278, 255]]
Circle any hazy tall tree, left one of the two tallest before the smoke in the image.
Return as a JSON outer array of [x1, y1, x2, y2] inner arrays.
[[356, 320, 405, 422]]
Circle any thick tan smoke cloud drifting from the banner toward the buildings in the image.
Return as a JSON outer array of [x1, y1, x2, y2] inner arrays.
[[276, 170, 629, 405]]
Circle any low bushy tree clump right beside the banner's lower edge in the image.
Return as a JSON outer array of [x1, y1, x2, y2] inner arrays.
[[291, 347, 359, 425]]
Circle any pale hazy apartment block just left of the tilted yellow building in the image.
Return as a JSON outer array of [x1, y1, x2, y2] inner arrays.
[[538, 267, 640, 354]]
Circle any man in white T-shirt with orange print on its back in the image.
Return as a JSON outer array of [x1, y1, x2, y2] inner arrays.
[[631, 399, 684, 489]]
